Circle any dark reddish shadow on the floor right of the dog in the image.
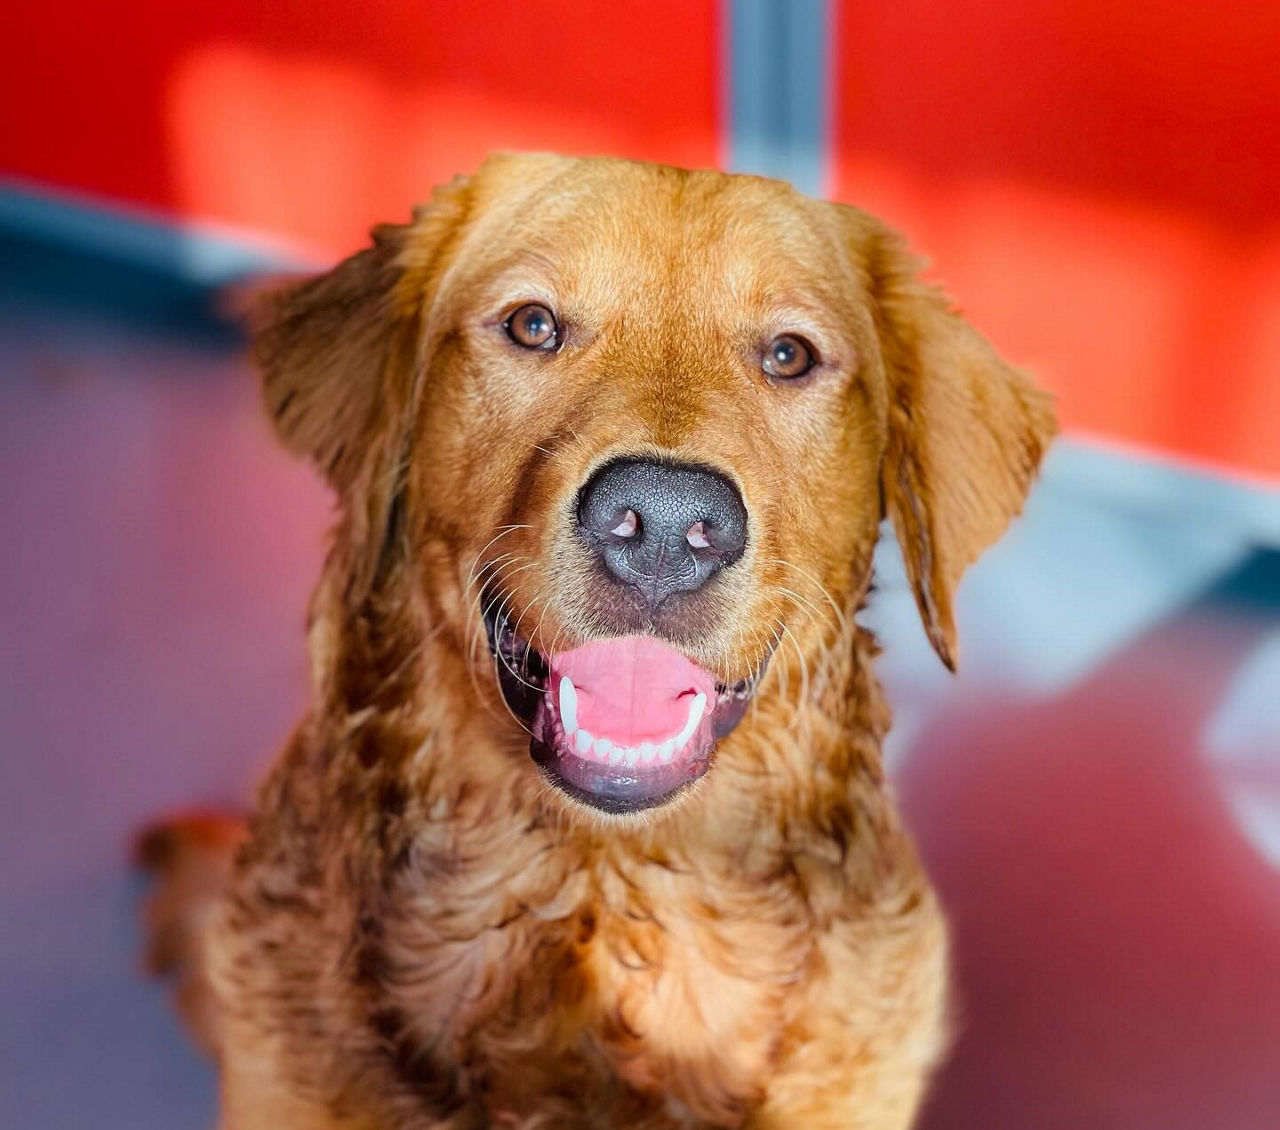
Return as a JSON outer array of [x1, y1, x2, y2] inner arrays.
[[900, 550, 1280, 1130]]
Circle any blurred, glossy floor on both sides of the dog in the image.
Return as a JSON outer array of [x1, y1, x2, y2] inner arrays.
[[0, 234, 1280, 1130]]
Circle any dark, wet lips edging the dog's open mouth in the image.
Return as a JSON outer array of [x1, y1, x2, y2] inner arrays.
[[483, 593, 769, 815]]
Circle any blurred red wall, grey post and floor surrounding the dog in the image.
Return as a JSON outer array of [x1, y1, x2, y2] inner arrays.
[[0, 0, 1280, 1130]]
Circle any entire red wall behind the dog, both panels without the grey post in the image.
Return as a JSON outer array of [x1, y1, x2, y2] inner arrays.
[[0, 0, 1280, 477]]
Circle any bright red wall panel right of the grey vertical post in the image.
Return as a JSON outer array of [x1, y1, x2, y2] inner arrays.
[[835, 0, 1280, 477]]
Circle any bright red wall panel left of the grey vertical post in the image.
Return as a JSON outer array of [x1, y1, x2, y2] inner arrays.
[[0, 0, 721, 252]]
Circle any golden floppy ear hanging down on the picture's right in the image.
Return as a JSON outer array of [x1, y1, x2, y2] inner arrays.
[[861, 216, 1056, 671]]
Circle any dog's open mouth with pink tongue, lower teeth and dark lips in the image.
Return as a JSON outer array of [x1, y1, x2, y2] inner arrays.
[[485, 599, 768, 813]]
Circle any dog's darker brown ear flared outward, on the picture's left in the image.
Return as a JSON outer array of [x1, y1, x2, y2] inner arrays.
[[248, 179, 466, 498]]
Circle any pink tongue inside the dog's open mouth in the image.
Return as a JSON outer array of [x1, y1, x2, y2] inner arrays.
[[549, 636, 716, 746]]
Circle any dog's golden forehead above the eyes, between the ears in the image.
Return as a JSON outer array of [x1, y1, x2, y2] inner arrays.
[[442, 157, 855, 309]]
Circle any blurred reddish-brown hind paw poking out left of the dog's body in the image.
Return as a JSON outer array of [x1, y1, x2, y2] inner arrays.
[[133, 811, 246, 1056]]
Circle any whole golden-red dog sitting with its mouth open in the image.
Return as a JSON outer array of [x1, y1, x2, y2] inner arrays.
[[140, 155, 1055, 1130]]
